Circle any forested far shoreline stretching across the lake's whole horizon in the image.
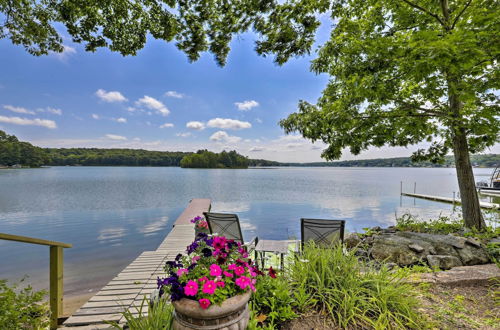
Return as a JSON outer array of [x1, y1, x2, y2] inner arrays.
[[0, 130, 500, 168]]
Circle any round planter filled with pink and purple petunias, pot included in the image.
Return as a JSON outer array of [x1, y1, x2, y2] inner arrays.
[[158, 233, 263, 329]]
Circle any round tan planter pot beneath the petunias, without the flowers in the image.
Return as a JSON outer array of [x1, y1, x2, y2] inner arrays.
[[172, 291, 252, 330]]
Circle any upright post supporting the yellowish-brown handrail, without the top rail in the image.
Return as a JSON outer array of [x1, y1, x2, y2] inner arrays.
[[50, 246, 63, 329]]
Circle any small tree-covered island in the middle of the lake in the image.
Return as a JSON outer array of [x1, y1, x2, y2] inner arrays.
[[181, 150, 249, 168]]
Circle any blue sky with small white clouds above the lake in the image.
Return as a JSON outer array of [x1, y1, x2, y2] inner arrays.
[[0, 30, 500, 162]]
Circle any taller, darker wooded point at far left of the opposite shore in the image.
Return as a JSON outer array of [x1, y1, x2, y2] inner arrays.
[[0, 130, 48, 167]]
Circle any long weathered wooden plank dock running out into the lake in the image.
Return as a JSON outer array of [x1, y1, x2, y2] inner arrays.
[[62, 199, 211, 330]]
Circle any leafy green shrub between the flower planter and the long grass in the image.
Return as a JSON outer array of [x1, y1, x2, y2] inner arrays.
[[250, 275, 297, 329]]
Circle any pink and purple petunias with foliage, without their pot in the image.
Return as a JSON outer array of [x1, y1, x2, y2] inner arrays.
[[158, 233, 263, 309]]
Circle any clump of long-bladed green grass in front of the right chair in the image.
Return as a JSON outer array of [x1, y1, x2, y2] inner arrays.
[[289, 244, 425, 329]]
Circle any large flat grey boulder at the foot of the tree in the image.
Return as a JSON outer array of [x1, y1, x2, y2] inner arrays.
[[370, 231, 489, 269]]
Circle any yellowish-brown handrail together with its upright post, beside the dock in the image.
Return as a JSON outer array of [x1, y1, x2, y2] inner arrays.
[[0, 233, 73, 329]]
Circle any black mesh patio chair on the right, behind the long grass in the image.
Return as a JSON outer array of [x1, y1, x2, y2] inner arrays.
[[300, 218, 345, 248]]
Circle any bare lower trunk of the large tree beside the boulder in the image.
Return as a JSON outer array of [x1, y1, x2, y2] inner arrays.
[[453, 128, 486, 230]]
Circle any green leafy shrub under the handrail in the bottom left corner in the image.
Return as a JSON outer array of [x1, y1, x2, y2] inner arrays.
[[0, 279, 50, 330]]
